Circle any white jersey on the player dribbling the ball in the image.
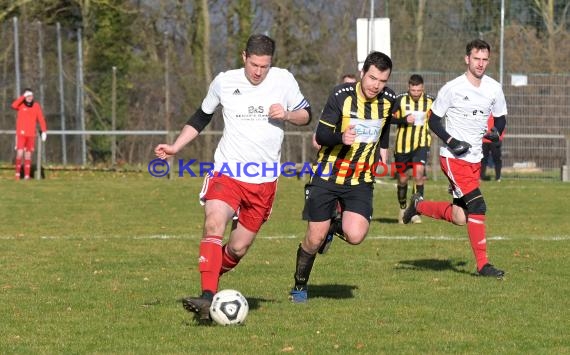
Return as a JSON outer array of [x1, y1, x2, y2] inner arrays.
[[202, 68, 309, 183]]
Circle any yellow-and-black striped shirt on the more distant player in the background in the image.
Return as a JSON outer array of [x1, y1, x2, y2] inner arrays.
[[392, 93, 434, 154]]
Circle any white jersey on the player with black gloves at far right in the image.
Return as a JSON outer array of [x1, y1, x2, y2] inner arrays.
[[431, 74, 507, 163]]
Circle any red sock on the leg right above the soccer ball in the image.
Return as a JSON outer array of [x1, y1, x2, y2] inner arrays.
[[198, 235, 224, 293]]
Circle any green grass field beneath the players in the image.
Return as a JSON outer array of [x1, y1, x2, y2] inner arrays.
[[0, 171, 570, 354]]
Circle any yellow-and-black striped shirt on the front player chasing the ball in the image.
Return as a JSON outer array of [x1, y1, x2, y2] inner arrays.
[[313, 82, 396, 185]]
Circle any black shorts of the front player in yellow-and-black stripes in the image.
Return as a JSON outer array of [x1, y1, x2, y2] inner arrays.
[[303, 176, 374, 222]]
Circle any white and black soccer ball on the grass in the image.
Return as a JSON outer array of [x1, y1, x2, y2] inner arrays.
[[206, 290, 249, 325]]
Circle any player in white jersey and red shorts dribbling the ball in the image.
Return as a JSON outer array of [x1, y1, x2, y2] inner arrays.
[[155, 35, 311, 322]]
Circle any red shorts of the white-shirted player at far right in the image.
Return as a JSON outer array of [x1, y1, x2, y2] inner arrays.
[[439, 156, 481, 198]]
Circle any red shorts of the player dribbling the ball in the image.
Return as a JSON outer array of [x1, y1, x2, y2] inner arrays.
[[200, 173, 277, 233]]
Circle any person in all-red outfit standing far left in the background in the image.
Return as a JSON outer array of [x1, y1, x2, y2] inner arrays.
[[12, 89, 47, 180]]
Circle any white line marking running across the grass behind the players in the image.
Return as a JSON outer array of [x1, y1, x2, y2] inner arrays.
[[0, 234, 570, 241]]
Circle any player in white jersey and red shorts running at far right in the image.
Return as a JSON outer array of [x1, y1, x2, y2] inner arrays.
[[403, 39, 507, 278]]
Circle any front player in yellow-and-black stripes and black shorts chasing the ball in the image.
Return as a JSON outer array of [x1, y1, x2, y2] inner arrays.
[[290, 52, 396, 303]]
